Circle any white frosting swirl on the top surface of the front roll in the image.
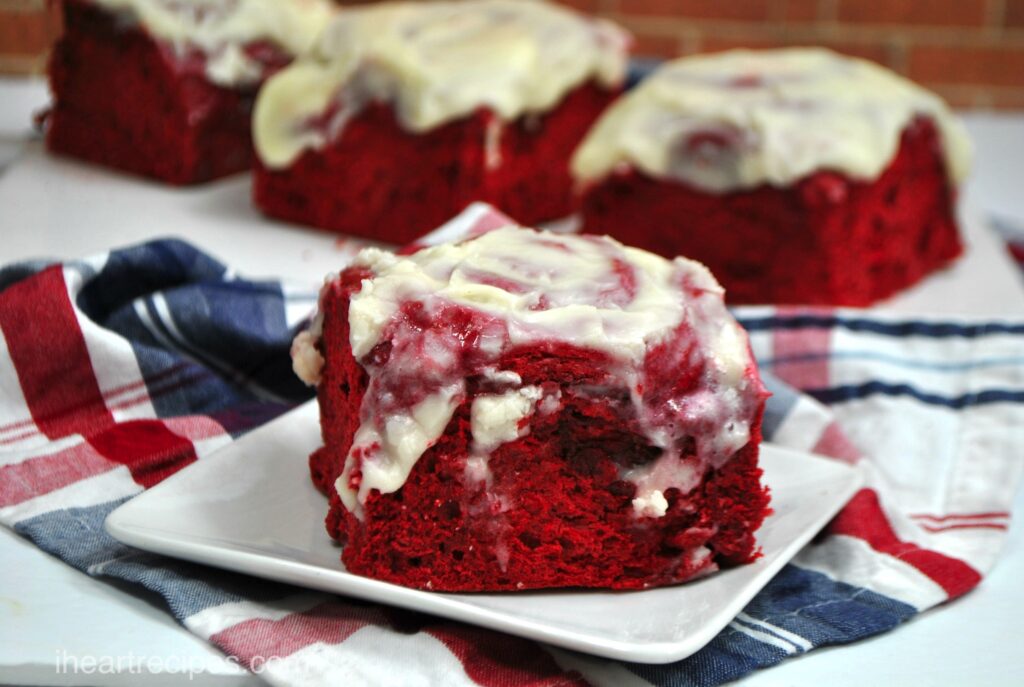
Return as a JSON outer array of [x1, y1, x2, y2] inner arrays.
[[348, 226, 700, 364]]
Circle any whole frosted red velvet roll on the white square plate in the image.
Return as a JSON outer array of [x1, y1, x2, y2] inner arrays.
[[292, 213, 768, 591]]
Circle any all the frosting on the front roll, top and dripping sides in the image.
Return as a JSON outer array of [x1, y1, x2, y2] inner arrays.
[[293, 226, 759, 517]]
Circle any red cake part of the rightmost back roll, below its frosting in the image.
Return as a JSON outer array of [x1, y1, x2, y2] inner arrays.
[[582, 118, 964, 306]]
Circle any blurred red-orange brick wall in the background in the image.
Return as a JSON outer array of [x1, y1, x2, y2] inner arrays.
[[0, 0, 1024, 110]]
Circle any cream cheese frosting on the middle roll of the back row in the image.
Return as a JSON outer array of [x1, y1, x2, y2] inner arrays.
[[253, 0, 628, 168]]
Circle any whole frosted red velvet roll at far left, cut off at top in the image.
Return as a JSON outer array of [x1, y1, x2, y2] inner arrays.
[[46, 0, 333, 184]]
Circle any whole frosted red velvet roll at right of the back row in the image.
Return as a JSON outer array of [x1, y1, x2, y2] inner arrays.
[[572, 48, 971, 305]]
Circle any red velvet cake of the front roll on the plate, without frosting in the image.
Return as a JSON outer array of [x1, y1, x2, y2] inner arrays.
[[299, 225, 768, 591]]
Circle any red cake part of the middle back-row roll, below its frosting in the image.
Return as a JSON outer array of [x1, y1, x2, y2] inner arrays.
[[253, 84, 617, 244]]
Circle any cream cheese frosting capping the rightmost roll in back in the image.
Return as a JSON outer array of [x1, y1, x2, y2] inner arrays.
[[572, 48, 971, 192]]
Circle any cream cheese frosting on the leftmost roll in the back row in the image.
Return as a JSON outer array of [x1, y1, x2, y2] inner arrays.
[[92, 0, 334, 86]]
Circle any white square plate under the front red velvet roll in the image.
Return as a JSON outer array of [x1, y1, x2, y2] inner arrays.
[[106, 401, 861, 663]]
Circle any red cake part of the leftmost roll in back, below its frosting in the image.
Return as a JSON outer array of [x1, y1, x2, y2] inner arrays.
[[46, 0, 290, 184]]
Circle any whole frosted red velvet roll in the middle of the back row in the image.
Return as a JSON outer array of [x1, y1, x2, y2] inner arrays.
[[254, 0, 628, 244]]
